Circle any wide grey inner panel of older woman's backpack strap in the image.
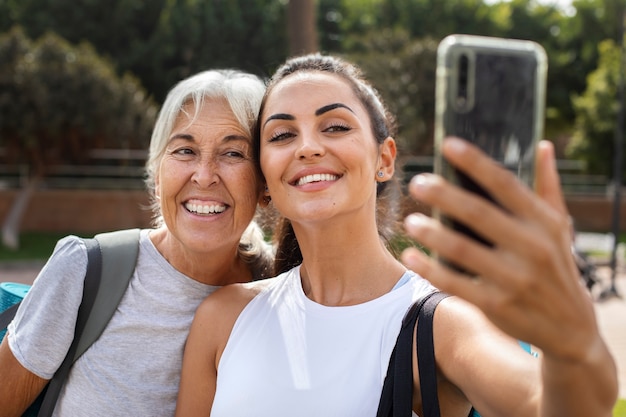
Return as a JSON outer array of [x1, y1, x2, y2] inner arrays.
[[73, 229, 139, 361]]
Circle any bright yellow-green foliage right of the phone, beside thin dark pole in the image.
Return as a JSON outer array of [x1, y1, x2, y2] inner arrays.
[[567, 40, 626, 180]]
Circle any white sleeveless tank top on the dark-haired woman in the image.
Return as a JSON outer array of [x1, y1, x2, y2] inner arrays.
[[211, 267, 434, 417]]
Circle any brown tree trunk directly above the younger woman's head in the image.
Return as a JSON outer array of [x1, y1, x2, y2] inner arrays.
[[287, 0, 319, 56]]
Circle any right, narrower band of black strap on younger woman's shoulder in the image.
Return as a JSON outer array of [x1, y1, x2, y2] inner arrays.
[[416, 292, 448, 417]]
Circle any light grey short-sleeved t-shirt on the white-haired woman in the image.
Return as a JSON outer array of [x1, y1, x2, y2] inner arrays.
[[8, 230, 217, 417]]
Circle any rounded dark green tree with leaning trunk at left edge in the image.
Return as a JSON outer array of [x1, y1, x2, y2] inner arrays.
[[0, 28, 157, 247]]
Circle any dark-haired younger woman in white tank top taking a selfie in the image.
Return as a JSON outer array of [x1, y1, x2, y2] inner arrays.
[[177, 55, 616, 417]]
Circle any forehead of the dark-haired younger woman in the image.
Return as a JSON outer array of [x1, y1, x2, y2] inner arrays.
[[264, 71, 363, 116]]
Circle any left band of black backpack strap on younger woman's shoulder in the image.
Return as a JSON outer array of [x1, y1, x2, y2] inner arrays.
[[376, 292, 447, 417]]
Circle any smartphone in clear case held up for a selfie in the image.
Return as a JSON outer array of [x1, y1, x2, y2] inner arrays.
[[433, 35, 547, 269]]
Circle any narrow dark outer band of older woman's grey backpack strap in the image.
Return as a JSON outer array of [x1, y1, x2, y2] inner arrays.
[[37, 239, 102, 417]]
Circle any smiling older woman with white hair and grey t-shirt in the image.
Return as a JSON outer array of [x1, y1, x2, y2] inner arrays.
[[0, 66, 271, 416]]
